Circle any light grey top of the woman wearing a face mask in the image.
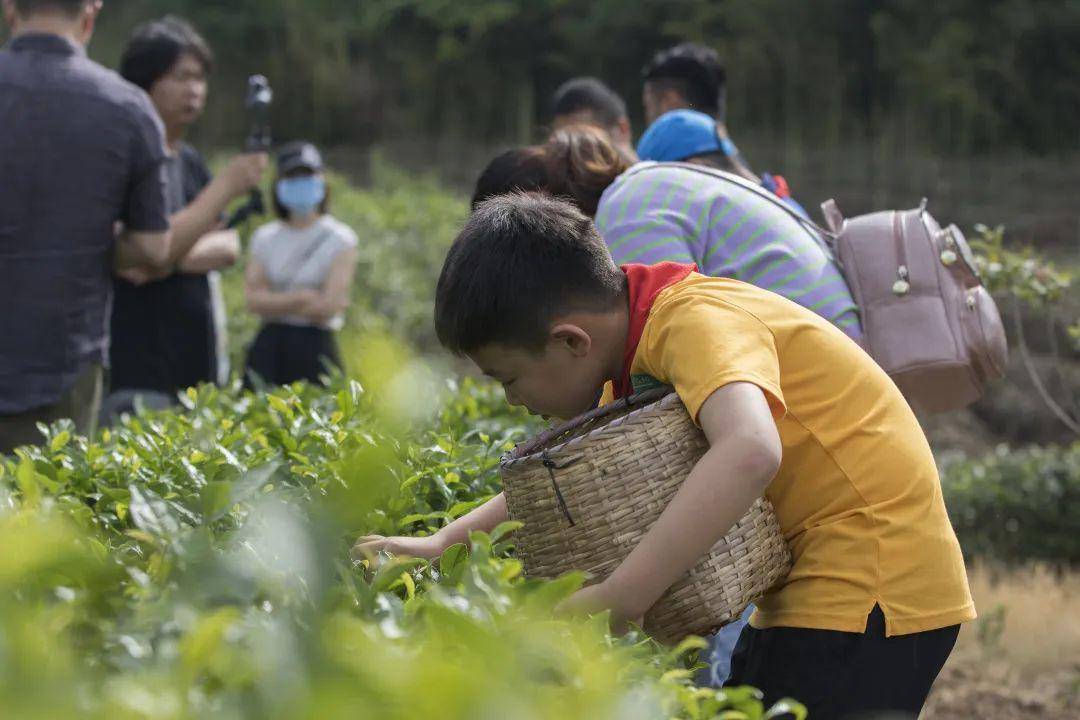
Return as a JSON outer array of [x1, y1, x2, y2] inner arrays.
[[252, 215, 357, 330]]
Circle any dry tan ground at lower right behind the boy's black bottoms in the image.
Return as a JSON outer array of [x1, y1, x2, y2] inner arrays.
[[922, 567, 1080, 720]]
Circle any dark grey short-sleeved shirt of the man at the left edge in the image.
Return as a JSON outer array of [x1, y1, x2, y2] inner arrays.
[[0, 35, 168, 415]]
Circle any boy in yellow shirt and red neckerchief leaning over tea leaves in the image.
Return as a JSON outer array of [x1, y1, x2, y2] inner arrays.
[[359, 194, 975, 718]]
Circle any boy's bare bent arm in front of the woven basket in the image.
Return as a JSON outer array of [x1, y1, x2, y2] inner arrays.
[[564, 382, 782, 628]]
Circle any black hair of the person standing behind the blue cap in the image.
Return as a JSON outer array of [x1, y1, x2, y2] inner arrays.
[[643, 42, 727, 122]]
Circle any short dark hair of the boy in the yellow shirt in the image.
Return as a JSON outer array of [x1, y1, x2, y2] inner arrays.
[[435, 192, 626, 355]]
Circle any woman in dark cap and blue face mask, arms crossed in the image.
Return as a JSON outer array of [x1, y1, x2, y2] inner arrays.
[[244, 142, 357, 386]]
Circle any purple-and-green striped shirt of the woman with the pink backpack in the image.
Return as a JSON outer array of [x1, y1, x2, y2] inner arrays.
[[596, 162, 862, 339]]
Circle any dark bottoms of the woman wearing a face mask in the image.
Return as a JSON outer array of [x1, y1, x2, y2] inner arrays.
[[244, 323, 341, 388]]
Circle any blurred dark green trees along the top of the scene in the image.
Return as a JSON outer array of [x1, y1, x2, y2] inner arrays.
[[79, 0, 1080, 154]]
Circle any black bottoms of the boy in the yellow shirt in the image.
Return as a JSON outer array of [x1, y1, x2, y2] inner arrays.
[[726, 606, 960, 720]]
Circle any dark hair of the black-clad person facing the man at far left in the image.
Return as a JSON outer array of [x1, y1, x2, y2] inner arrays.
[[120, 15, 214, 92]]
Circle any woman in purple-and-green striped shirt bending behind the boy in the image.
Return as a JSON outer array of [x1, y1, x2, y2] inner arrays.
[[473, 125, 862, 340]]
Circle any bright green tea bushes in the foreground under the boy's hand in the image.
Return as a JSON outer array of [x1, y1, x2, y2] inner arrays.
[[0, 377, 798, 719]]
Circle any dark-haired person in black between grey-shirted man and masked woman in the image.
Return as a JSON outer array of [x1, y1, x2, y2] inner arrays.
[[105, 17, 267, 416]]
